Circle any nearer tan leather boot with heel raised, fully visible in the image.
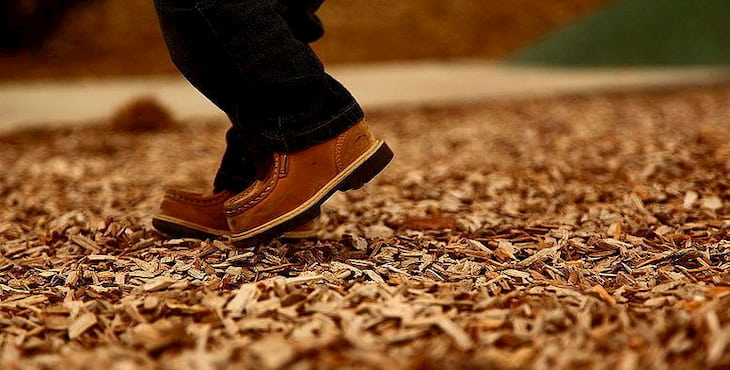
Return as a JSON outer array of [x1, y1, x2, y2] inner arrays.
[[225, 122, 393, 246]]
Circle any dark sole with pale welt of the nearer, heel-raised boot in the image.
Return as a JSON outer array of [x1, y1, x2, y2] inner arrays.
[[231, 141, 393, 247]]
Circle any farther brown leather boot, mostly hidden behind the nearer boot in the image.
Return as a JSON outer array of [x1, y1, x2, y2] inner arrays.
[[152, 189, 317, 239]]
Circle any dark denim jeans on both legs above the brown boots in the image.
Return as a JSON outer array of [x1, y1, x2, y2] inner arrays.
[[155, 0, 363, 190]]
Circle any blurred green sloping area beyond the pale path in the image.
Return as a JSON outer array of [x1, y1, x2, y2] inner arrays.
[[508, 0, 730, 66]]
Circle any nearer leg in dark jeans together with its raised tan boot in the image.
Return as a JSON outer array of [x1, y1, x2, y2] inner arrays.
[[157, 0, 392, 245]]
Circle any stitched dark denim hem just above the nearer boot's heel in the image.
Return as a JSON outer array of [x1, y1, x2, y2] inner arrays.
[[261, 100, 365, 153]]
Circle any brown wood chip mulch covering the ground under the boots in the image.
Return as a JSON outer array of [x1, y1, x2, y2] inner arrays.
[[0, 85, 730, 370]]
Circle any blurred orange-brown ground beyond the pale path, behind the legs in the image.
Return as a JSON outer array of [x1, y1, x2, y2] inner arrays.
[[0, 0, 608, 80]]
